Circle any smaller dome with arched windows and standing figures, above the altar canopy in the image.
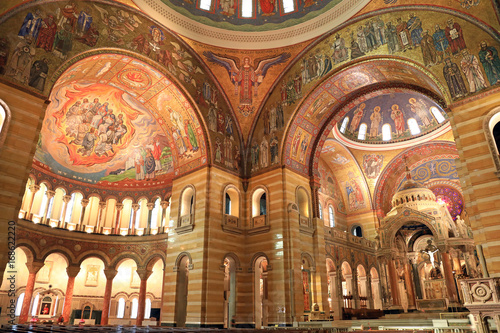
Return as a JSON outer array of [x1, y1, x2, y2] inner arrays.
[[335, 89, 448, 145]]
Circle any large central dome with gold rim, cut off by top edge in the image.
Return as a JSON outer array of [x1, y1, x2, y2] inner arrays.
[[133, 0, 370, 50]]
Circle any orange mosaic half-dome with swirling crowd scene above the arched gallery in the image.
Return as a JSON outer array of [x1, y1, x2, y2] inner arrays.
[[35, 54, 206, 188]]
